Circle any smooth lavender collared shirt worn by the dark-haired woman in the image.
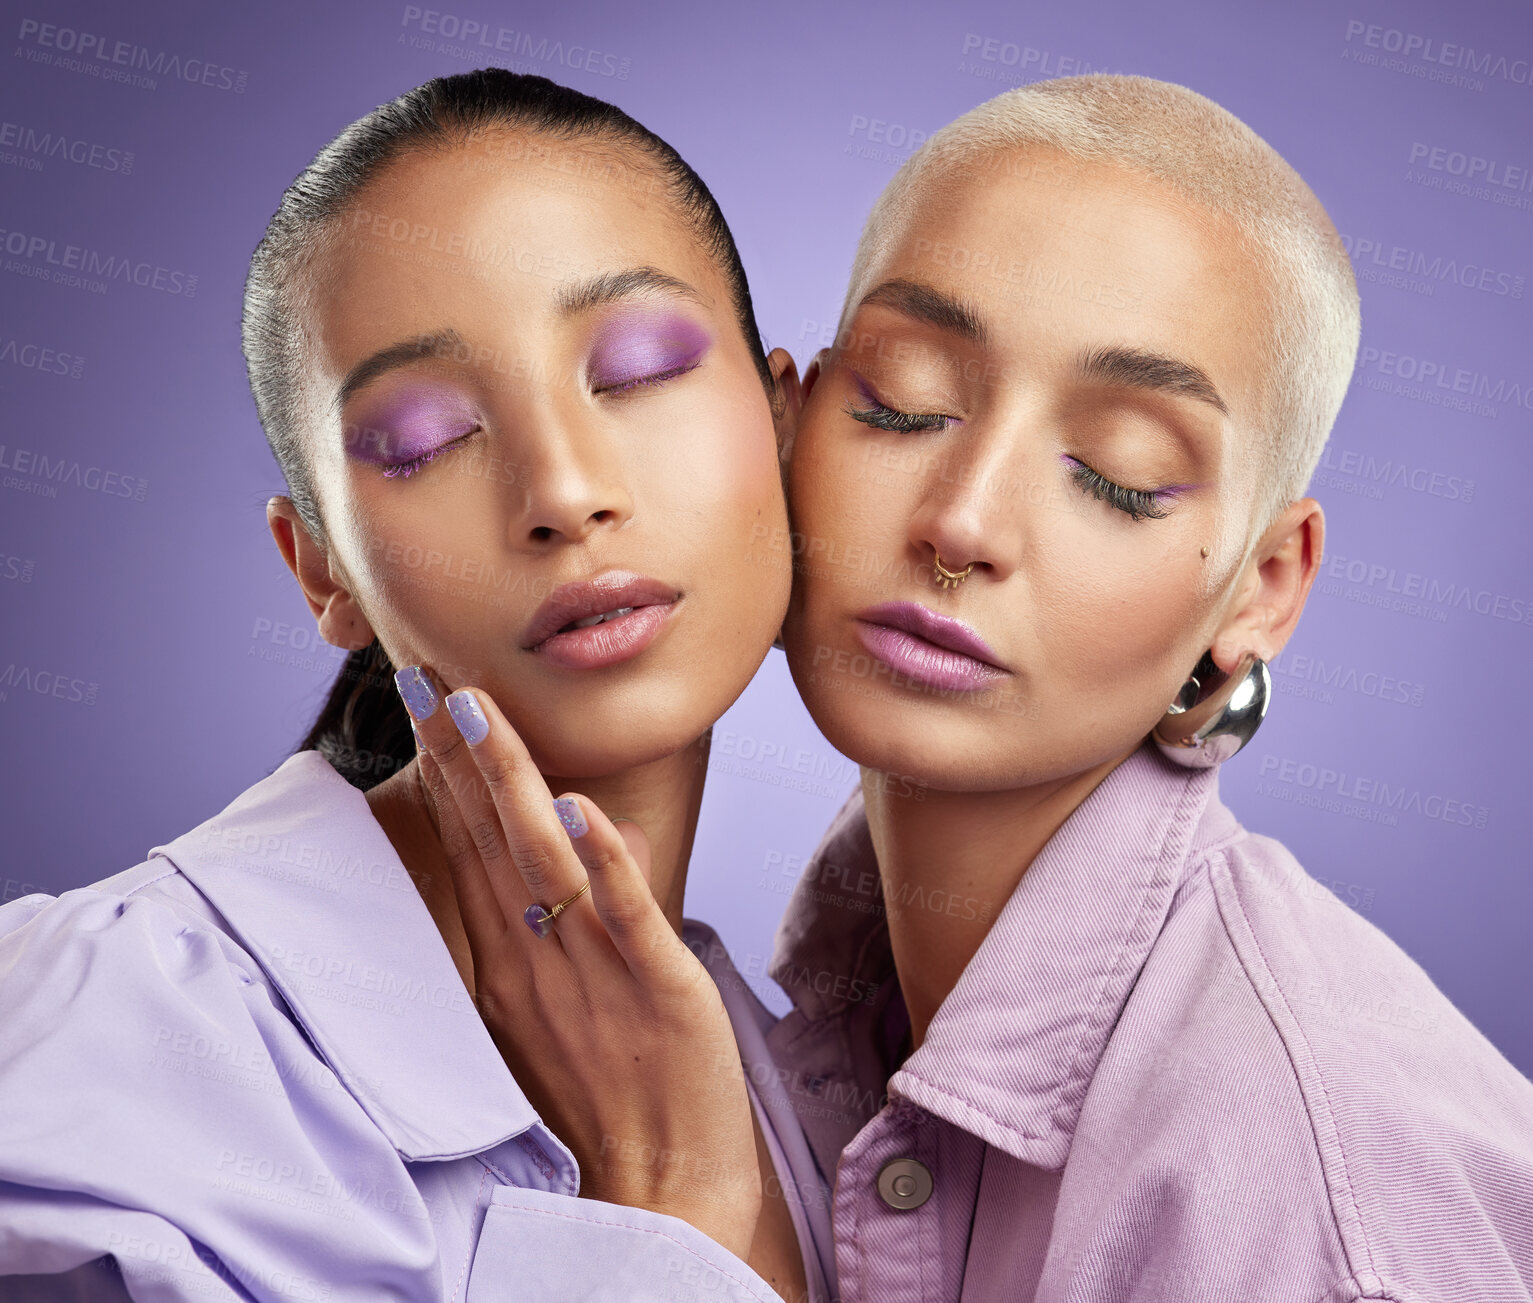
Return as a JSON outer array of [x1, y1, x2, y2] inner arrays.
[[0, 751, 829, 1303]]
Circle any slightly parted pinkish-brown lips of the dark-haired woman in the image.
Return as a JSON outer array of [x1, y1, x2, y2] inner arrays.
[[521, 570, 681, 670]]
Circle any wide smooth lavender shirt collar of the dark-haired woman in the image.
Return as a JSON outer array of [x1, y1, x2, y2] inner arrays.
[[149, 751, 552, 1162]]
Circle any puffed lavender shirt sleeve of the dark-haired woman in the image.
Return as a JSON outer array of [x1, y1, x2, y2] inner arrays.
[[0, 888, 442, 1303]]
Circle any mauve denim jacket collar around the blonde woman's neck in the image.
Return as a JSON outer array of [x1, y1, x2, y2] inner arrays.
[[771, 743, 1242, 1168]]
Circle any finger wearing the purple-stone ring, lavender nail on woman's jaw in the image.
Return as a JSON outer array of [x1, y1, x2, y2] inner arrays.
[[446, 688, 586, 924]]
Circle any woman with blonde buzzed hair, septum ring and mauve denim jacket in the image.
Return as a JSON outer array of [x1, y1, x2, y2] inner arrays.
[[770, 75, 1533, 1303]]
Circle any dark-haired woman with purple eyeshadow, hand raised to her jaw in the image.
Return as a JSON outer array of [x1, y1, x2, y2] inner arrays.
[[0, 69, 832, 1303]]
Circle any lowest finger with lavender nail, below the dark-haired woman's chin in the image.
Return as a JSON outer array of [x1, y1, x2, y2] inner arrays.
[[553, 793, 676, 973]]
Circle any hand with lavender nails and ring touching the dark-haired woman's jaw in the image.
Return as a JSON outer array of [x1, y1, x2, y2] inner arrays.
[[389, 667, 762, 1259]]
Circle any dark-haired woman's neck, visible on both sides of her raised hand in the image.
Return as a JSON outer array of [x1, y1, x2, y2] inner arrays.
[[366, 731, 711, 993]]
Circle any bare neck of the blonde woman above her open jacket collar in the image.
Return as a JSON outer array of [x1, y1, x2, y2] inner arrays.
[[863, 735, 1131, 1052]]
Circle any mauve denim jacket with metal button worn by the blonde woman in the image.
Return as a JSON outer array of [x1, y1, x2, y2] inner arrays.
[[768, 745, 1533, 1303]]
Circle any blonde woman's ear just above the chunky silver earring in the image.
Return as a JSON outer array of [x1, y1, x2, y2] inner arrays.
[[1210, 498, 1326, 674]]
